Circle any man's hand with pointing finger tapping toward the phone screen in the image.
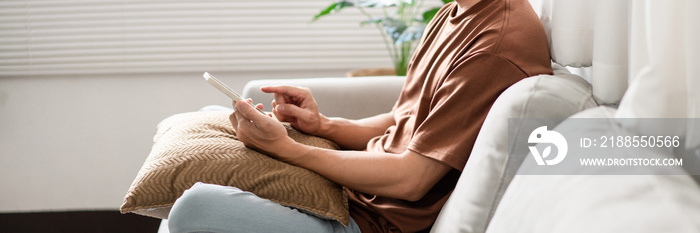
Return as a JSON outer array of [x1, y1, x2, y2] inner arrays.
[[261, 86, 325, 136]]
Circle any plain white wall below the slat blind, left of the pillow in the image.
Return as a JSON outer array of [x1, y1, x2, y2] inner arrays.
[[0, 70, 346, 212]]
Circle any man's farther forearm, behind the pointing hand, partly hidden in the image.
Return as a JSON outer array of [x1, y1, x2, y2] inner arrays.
[[317, 113, 394, 150]]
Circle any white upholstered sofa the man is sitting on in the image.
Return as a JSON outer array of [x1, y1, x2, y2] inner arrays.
[[235, 64, 700, 232]]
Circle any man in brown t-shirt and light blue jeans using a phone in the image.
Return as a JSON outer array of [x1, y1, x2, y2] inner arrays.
[[170, 0, 552, 232]]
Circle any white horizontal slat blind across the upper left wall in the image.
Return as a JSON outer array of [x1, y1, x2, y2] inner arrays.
[[0, 0, 402, 76]]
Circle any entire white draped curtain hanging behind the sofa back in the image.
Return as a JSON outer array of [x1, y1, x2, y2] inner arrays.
[[530, 0, 700, 148]]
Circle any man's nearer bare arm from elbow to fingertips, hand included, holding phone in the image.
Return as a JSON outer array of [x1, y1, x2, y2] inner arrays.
[[231, 102, 452, 201]]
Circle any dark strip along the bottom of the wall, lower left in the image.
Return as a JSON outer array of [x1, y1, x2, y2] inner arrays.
[[0, 210, 161, 233]]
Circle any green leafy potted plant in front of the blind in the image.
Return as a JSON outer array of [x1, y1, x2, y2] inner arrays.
[[312, 0, 453, 75]]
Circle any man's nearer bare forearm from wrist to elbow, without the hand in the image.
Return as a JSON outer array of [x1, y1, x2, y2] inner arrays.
[[279, 140, 451, 201]]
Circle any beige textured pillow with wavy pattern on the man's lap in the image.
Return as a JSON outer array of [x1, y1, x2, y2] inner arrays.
[[120, 112, 350, 225]]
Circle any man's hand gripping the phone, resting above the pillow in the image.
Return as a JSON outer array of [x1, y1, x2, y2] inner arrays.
[[229, 100, 294, 161]]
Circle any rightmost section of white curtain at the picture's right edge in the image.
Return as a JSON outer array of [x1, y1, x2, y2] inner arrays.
[[616, 0, 700, 148]]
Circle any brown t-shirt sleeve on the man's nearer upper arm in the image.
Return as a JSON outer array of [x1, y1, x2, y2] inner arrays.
[[408, 53, 526, 171]]
